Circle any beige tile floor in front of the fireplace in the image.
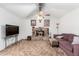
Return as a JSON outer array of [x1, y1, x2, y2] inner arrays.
[[0, 40, 66, 56]]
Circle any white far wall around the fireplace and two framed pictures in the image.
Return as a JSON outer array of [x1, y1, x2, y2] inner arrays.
[[26, 15, 58, 36]]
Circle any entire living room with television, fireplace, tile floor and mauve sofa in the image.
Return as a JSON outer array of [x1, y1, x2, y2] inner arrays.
[[0, 3, 79, 56]]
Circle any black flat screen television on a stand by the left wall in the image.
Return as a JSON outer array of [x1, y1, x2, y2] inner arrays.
[[6, 25, 19, 36]]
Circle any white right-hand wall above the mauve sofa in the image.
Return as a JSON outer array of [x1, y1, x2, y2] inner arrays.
[[59, 8, 79, 35]]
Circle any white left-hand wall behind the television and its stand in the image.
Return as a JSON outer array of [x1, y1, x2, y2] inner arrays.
[[0, 8, 26, 50]]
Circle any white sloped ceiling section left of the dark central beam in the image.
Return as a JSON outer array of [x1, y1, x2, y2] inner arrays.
[[0, 3, 37, 18]]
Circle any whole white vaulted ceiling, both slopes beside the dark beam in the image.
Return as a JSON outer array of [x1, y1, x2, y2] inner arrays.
[[0, 3, 79, 18]]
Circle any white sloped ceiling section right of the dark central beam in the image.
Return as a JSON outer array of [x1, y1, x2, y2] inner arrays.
[[44, 3, 79, 18]]
